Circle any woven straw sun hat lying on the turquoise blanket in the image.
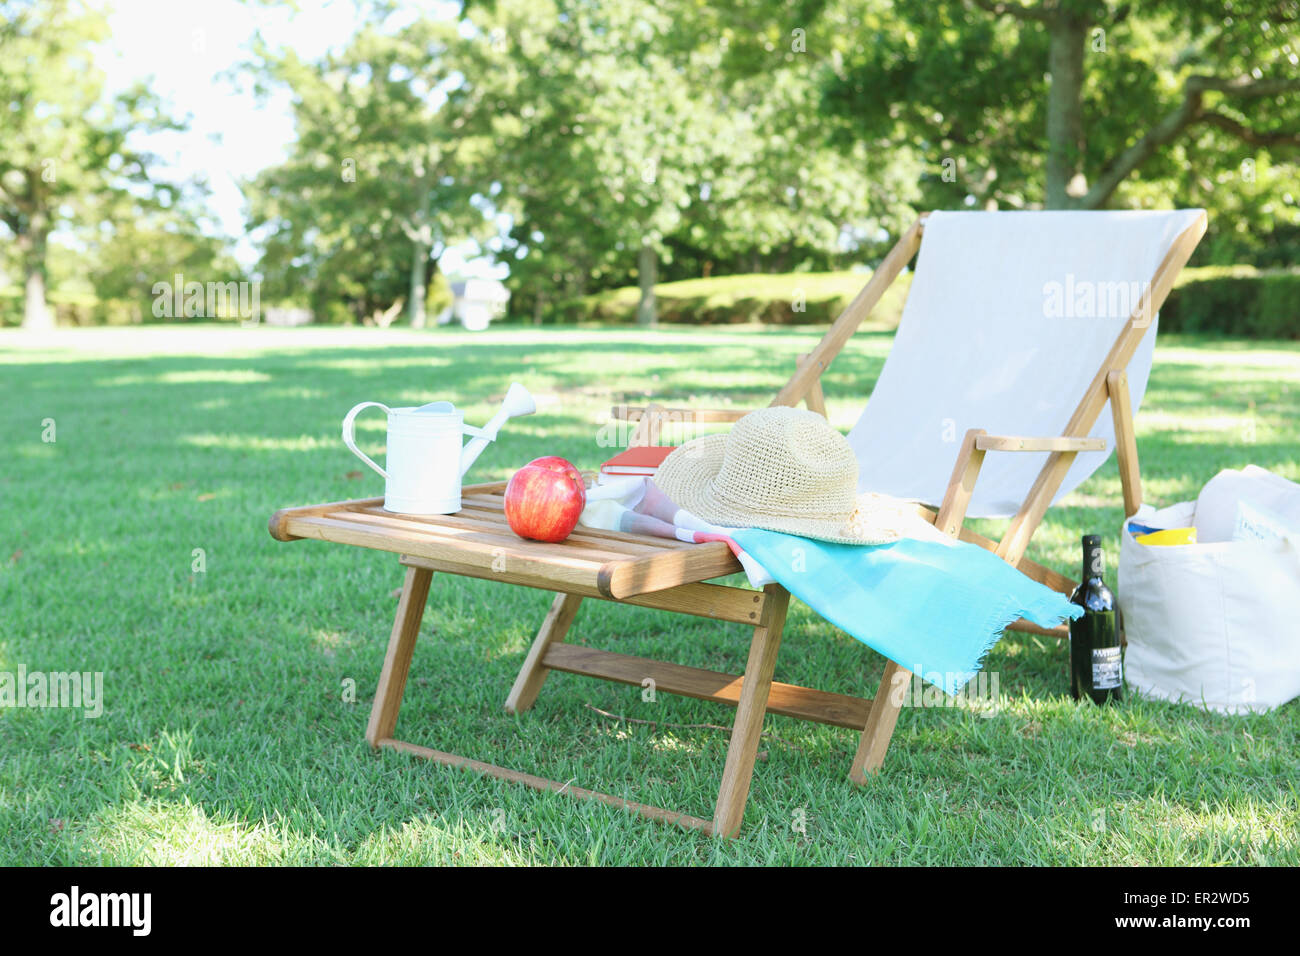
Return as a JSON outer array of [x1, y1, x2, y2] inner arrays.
[[654, 406, 904, 545]]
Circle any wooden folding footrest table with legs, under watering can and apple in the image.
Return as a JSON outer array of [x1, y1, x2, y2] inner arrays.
[[270, 483, 863, 835]]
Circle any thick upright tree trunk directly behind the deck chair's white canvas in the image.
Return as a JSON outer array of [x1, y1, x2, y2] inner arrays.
[[1047, 13, 1088, 209]]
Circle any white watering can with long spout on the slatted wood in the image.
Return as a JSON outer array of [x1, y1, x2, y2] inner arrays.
[[343, 382, 537, 515]]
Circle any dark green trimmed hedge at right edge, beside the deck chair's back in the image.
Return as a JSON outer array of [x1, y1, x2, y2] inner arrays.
[[1160, 265, 1300, 338]]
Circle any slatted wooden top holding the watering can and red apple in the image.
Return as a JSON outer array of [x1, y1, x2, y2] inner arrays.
[[270, 483, 742, 600]]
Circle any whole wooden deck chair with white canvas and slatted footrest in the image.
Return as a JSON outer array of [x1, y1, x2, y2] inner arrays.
[[270, 209, 1206, 836]]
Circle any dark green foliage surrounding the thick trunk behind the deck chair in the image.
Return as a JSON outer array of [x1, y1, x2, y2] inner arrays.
[[759, 0, 1300, 264]]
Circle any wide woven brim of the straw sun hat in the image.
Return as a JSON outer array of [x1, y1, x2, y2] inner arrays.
[[654, 434, 904, 545]]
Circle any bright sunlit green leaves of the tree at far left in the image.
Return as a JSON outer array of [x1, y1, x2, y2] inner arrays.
[[0, 0, 220, 325]]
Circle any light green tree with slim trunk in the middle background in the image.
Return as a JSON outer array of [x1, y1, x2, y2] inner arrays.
[[468, 0, 728, 325]]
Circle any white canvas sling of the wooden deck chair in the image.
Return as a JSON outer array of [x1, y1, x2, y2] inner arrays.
[[849, 209, 1205, 518]]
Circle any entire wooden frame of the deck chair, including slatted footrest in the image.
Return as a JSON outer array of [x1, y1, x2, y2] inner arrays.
[[270, 215, 1206, 836]]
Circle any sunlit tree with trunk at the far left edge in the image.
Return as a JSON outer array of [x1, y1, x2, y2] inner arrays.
[[0, 0, 176, 329]]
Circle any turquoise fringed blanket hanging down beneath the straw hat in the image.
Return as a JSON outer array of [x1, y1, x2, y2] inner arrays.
[[732, 528, 1083, 693]]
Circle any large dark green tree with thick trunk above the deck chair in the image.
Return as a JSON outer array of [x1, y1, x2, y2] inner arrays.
[[806, 0, 1300, 215]]
